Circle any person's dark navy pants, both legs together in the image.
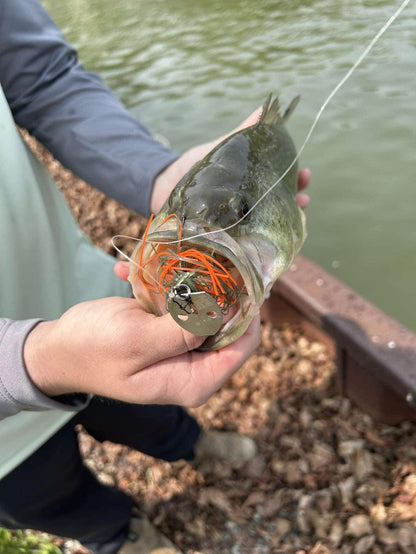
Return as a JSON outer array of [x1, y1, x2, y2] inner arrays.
[[0, 399, 200, 554]]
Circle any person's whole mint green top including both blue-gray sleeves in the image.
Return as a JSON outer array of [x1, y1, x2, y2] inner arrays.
[[0, 0, 176, 479]]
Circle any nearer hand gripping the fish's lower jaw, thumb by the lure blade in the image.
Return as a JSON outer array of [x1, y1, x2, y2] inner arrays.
[[24, 297, 260, 407]]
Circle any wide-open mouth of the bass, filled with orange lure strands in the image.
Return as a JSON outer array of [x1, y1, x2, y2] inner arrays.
[[129, 216, 265, 350]]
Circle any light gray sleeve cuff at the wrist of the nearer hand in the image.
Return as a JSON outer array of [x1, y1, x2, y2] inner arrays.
[[0, 318, 89, 420]]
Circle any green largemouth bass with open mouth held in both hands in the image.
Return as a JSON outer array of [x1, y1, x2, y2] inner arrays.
[[129, 95, 307, 351]]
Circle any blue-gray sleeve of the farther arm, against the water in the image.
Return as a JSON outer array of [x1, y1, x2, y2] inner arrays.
[[0, 0, 177, 215]]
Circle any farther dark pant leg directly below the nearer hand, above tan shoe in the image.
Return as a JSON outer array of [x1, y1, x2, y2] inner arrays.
[[76, 398, 200, 461]]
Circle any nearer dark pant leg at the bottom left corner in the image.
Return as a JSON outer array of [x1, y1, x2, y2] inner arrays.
[[0, 420, 133, 554]]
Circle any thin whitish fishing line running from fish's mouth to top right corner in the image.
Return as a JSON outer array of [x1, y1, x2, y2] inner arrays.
[[168, 0, 410, 244]]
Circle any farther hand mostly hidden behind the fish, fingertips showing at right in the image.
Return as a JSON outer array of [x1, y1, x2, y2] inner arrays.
[[150, 108, 311, 214]]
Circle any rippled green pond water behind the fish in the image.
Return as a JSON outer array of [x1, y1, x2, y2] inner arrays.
[[42, 0, 416, 331]]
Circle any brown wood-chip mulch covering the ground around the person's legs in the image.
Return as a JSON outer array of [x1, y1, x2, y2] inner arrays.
[[21, 136, 416, 554]]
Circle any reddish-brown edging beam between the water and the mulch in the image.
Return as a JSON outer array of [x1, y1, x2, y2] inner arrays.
[[262, 255, 416, 425]]
